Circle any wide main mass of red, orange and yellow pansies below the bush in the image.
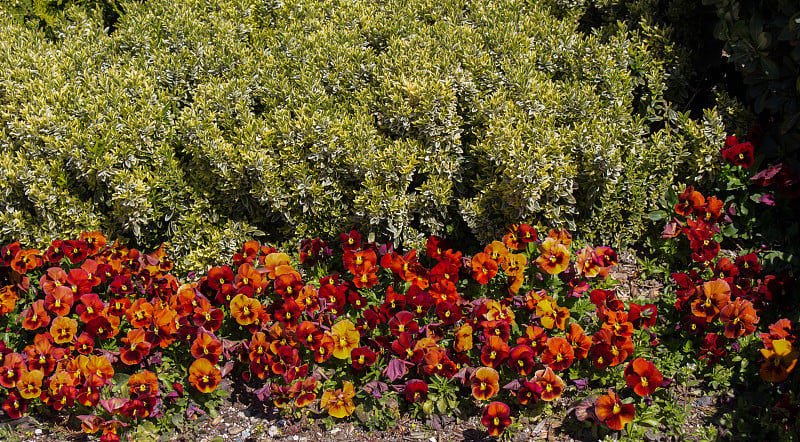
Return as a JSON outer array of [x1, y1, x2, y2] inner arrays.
[[0, 224, 662, 440]]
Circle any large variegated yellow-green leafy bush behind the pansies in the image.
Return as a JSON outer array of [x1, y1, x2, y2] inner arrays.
[[0, 0, 723, 269]]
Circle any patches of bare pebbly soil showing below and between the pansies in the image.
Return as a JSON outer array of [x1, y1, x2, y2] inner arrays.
[[0, 251, 727, 442]]
